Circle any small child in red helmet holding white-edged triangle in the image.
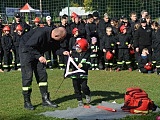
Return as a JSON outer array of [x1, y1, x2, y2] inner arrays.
[[71, 38, 91, 106]]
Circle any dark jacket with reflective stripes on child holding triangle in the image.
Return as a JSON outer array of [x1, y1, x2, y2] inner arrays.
[[71, 51, 90, 79]]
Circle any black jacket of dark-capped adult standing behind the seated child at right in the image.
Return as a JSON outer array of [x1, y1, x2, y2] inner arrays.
[[134, 26, 152, 47]]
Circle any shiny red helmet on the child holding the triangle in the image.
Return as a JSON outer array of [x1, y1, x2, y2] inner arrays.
[[76, 38, 88, 51]]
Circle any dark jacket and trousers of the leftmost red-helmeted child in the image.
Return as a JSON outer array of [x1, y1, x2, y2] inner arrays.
[[1, 34, 13, 72]]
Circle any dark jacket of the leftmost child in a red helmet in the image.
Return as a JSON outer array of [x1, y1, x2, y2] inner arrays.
[[1, 35, 13, 52]]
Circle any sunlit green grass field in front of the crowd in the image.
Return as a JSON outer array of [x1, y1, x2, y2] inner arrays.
[[0, 69, 160, 120]]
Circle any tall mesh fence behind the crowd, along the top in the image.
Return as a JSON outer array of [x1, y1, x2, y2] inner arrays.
[[0, 0, 160, 22]]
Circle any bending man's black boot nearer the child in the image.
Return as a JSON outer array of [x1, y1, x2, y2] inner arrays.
[[42, 93, 58, 108]]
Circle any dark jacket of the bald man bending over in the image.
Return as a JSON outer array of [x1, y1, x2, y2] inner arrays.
[[20, 27, 52, 60]]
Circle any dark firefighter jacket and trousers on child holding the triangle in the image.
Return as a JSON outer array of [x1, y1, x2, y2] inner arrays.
[[71, 52, 90, 101]]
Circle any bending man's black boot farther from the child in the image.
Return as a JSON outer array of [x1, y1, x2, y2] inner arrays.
[[24, 96, 34, 110]]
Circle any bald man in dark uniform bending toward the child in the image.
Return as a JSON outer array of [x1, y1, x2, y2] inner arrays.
[[19, 27, 66, 110]]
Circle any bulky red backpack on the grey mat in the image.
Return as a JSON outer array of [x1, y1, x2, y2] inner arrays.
[[121, 88, 154, 114]]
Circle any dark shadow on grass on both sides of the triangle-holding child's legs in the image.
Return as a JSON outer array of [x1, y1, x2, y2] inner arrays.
[[54, 91, 124, 105]]
